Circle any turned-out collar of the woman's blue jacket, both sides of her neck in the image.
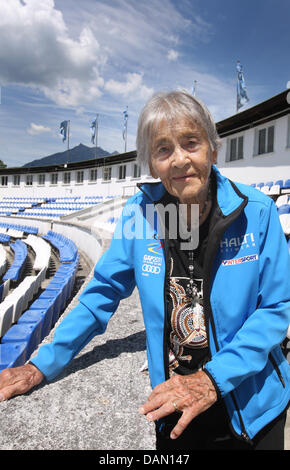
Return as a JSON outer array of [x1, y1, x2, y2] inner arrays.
[[138, 165, 247, 217]]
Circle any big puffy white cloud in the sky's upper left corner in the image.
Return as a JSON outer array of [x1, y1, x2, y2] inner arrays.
[[0, 0, 107, 106]]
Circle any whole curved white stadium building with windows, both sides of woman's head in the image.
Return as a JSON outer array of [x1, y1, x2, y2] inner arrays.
[[0, 90, 290, 199]]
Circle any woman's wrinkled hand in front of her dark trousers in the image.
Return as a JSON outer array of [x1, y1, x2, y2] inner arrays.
[[139, 371, 217, 439]]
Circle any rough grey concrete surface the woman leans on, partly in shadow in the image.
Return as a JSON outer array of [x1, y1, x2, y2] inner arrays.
[[0, 246, 290, 450]]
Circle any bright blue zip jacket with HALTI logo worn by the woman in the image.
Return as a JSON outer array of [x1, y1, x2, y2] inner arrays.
[[31, 166, 290, 439]]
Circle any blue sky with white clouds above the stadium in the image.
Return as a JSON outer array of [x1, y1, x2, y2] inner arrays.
[[0, 0, 290, 167]]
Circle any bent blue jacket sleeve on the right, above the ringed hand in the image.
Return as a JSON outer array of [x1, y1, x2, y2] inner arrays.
[[205, 201, 290, 396]]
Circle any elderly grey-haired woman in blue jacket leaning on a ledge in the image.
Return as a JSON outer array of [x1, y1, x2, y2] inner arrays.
[[0, 91, 290, 450]]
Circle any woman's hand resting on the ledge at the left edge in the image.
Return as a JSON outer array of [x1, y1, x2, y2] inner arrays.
[[0, 364, 44, 401]]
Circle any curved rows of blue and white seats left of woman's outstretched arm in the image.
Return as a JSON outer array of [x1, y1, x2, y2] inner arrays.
[[0, 224, 80, 371]]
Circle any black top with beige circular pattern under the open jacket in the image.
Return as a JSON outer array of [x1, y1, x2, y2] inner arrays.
[[162, 182, 214, 375]]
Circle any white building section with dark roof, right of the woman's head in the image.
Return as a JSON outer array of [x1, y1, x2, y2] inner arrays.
[[217, 90, 290, 184]]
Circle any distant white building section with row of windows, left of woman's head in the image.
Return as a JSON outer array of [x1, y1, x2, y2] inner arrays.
[[0, 151, 151, 199]]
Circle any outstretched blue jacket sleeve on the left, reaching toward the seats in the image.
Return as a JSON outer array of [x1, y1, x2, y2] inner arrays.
[[30, 206, 135, 380]]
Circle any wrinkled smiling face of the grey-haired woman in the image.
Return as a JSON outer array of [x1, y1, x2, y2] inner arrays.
[[149, 119, 217, 204]]
